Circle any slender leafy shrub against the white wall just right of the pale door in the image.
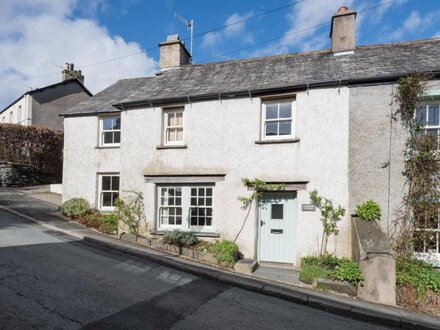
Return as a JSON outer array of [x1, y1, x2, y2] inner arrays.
[[310, 190, 345, 255]]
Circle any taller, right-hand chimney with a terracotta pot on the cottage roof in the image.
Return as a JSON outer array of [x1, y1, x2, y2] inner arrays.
[[330, 6, 356, 55]]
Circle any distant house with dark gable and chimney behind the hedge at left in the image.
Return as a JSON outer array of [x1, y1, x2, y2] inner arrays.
[[0, 63, 93, 129]]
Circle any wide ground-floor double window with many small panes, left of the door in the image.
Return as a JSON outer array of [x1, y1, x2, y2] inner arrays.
[[158, 185, 214, 232]]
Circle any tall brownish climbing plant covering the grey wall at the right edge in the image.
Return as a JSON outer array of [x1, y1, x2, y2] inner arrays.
[[392, 73, 440, 256]]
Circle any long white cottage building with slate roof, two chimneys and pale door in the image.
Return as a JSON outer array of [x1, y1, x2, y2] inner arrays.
[[63, 7, 440, 265]]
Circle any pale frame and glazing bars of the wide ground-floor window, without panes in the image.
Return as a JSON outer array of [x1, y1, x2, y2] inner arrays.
[[156, 184, 215, 233]]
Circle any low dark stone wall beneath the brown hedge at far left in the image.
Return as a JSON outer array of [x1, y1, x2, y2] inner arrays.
[[0, 161, 61, 187]]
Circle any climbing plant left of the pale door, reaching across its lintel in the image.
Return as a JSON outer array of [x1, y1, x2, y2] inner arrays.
[[234, 178, 286, 243]]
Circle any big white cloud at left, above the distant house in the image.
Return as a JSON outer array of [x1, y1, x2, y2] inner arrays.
[[0, 0, 157, 108]]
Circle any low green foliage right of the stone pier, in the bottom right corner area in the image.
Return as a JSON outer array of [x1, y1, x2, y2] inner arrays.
[[396, 257, 440, 296]]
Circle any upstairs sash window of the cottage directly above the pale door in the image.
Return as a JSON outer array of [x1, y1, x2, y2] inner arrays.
[[261, 100, 295, 140]]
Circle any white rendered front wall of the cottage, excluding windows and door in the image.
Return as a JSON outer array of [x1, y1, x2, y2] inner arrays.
[[63, 88, 351, 263]]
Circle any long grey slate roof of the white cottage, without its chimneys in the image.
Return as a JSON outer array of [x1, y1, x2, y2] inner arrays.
[[65, 39, 440, 116]]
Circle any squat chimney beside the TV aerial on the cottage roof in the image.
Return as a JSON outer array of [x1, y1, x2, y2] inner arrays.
[[159, 34, 191, 70]]
